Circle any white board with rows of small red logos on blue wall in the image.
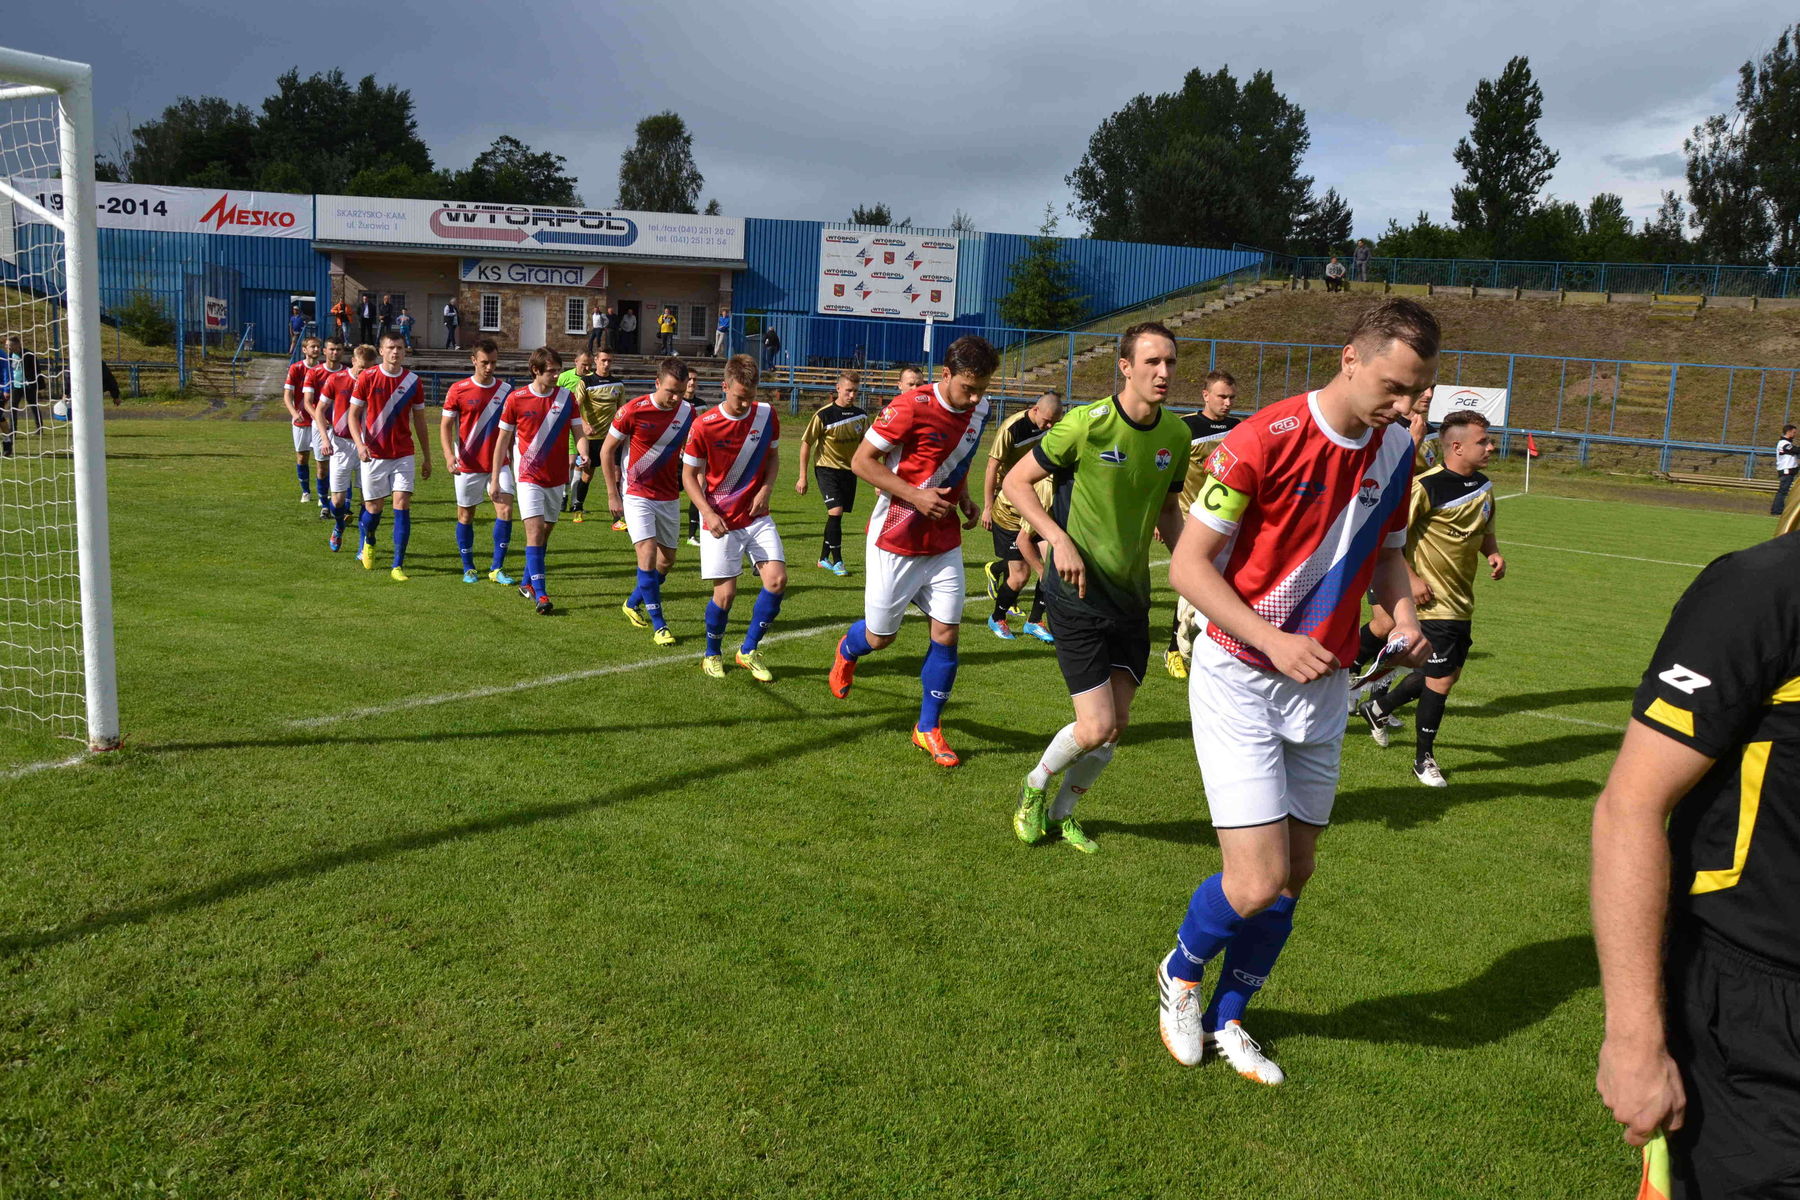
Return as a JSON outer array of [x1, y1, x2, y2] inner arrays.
[[819, 228, 958, 320]]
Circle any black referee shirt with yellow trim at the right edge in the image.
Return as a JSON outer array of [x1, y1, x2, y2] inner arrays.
[[1631, 533, 1800, 972]]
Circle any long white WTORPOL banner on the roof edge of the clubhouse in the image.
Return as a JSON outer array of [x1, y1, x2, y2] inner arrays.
[[317, 196, 743, 259]]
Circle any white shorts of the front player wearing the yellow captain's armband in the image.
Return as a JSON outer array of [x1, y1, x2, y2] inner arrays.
[[1188, 624, 1350, 829]]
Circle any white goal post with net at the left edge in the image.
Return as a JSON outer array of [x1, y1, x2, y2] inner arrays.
[[0, 47, 119, 750]]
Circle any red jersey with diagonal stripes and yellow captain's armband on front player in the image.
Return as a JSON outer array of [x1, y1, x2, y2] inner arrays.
[[1190, 392, 1413, 669]]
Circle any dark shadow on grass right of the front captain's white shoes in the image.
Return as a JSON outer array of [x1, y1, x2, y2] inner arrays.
[[1256, 936, 1600, 1049]]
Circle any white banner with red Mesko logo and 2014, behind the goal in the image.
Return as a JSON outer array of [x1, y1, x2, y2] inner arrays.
[[13, 178, 313, 237]]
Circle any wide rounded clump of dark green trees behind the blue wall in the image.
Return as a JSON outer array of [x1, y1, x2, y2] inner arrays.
[[1067, 67, 1312, 246]]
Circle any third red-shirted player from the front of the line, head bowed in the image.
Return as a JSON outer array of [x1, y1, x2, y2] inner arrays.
[[680, 354, 787, 684]]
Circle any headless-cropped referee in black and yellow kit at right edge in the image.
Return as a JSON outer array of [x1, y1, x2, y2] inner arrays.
[[1593, 533, 1800, 1200]]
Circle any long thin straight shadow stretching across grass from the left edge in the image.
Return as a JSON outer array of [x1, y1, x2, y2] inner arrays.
[[0, 712, 893, 955]]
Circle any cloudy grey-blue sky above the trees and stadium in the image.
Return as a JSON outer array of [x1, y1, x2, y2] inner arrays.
[[0, 0, 1796, 236]]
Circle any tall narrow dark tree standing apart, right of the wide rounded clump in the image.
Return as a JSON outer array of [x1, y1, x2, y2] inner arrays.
[[1451, 56, 1557, 257]]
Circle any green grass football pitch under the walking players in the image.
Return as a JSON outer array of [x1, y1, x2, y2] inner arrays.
[[0, 421, 1769, 1200]]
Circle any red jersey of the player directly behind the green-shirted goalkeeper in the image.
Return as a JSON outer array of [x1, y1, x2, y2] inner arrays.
[[864, 385, 988, 556]]
